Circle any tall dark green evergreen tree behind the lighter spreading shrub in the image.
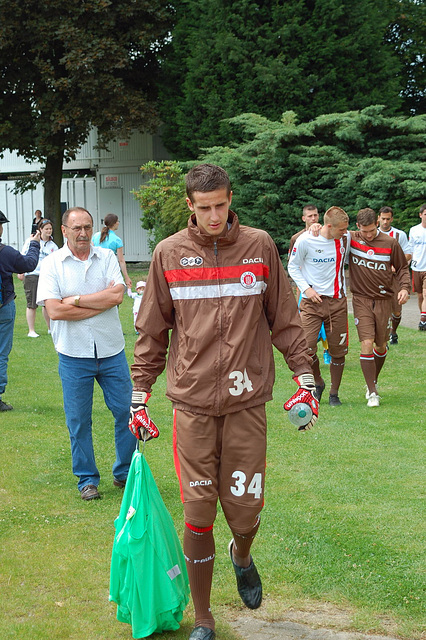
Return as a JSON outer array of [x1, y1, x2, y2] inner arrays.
[[161, 0, 402, 158]]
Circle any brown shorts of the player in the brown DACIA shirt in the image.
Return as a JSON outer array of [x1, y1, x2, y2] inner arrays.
[[352, 295, 392, 345]]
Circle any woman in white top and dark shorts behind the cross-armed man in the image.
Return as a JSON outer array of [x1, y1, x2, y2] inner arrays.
[[18, 219, 58, 338]]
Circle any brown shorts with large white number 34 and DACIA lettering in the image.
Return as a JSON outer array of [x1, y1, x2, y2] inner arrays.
[[173, 405, 266, 534]]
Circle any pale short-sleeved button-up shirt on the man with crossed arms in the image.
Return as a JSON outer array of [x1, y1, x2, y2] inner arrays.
[[37, 245, 124, 358]]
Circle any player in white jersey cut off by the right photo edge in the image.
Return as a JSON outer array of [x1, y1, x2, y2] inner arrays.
[[409, 204, 426, 331]]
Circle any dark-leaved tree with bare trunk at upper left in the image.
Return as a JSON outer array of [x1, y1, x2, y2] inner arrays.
[[0, 0, 171, 239]]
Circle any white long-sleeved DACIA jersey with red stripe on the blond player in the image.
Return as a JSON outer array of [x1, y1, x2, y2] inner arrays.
[[288, 231, 349, 298]]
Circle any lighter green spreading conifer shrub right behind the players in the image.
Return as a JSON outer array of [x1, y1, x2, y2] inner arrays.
[[202, 105, 426, 253]]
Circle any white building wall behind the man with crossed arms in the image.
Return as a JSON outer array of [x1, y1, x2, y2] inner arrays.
[[0, 129, 168, 262]]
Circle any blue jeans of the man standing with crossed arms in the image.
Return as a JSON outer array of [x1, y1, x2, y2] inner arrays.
[[59, 351, 137, 491]]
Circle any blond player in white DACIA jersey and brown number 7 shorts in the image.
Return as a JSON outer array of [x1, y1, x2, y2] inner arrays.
[[288, 207, 349, 406]]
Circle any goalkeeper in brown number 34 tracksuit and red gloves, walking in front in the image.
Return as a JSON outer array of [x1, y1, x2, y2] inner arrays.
[[130, 164, 318, 640]]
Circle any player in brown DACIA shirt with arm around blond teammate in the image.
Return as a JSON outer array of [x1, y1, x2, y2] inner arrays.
[[349, 209, 410, 407]]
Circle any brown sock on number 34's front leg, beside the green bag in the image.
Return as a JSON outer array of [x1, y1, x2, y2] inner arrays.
[[183, 524, 215, 629]]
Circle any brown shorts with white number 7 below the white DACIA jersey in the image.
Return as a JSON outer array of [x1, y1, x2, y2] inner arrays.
[[300, 297, 348, 358]]
